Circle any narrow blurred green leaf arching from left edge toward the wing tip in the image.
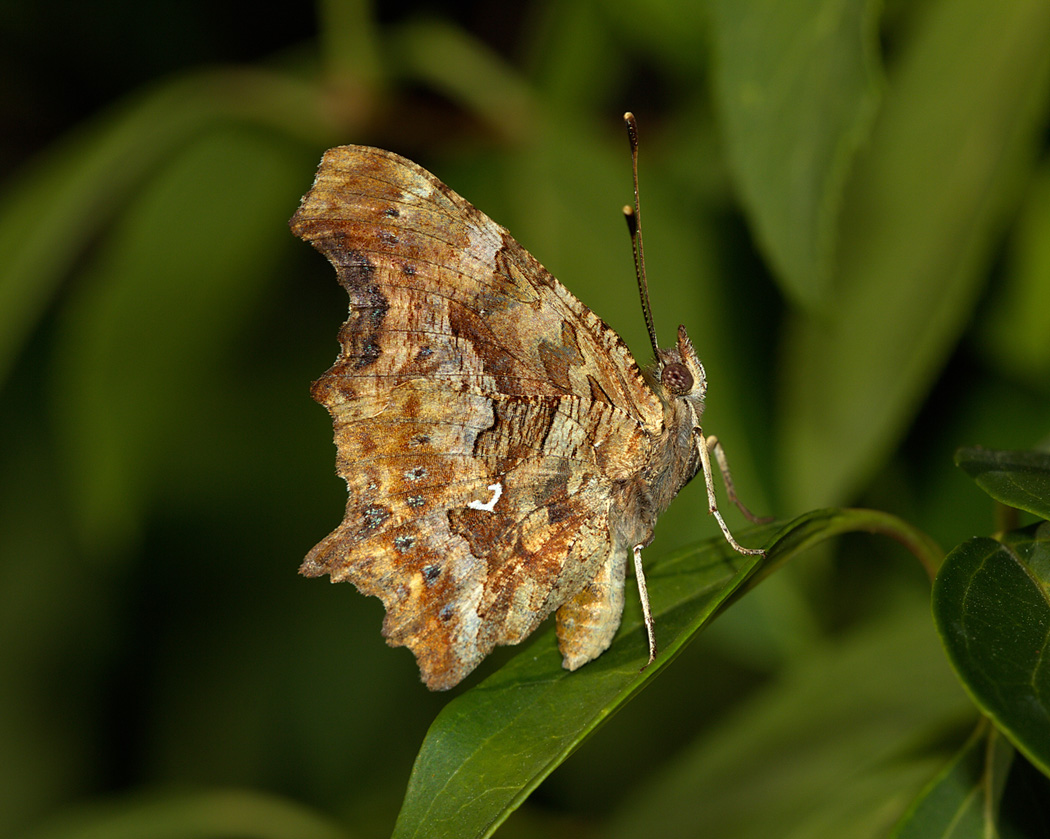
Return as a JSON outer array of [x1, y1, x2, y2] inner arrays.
[[0, 70, 333, 383]]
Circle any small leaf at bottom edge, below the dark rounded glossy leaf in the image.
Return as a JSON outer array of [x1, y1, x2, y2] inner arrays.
[[893, 722, 1014, 839]]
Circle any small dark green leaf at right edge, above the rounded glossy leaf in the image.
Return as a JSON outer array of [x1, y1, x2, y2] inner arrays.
[[956, 448, 1050, 520]]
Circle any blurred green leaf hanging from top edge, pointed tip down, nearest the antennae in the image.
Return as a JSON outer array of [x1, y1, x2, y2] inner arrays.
[[712, 0, 880, 309]]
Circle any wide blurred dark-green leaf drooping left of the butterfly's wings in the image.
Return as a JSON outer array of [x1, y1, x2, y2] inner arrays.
[[53, 129, 312, 553]]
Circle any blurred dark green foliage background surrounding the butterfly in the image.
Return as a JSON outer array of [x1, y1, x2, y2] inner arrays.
[[0, 0, 1050, 837]]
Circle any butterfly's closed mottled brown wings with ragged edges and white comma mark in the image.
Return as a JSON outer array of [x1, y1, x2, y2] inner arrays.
[[292, 146, 663, 689]]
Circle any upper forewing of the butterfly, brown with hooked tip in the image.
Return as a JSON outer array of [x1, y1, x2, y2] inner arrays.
[[291, 146, 663, 426]]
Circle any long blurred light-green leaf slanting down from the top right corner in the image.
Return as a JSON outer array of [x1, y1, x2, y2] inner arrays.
[[777, 0, 1050, 507]]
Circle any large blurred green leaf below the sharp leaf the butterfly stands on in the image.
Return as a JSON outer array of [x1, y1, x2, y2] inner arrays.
[[602, 599, 972, 839]]
